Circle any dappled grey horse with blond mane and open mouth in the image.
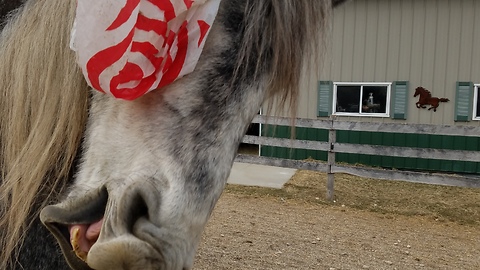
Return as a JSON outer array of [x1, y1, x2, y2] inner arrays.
[[0, 0, 344, 269]]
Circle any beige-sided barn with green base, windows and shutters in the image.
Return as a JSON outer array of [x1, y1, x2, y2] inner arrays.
[[260, 0, 480, 173]]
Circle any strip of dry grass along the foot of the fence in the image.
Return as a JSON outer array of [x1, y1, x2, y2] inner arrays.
[[226, 171, 480, 227]]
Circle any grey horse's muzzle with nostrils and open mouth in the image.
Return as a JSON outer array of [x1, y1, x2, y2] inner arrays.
[[40, 182, 194, 270]]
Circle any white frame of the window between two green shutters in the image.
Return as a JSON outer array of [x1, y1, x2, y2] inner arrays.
[[332, 82, 392, 117]]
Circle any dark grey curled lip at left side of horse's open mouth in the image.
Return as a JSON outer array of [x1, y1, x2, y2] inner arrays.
[[40, 187, 108, 270]]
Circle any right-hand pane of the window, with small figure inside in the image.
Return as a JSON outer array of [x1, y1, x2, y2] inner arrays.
[[362, 85, 387, 113]]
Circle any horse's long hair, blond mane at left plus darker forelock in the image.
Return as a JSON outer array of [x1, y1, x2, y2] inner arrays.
[[0, 0, 331, 269]]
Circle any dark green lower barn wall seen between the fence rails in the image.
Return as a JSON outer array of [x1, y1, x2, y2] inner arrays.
[[260, 126, 480, 174]]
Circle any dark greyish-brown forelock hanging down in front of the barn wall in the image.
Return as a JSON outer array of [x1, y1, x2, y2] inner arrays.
[[237, 0, 332, 119]]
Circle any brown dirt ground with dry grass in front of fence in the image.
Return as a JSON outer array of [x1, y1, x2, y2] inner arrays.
[[194, 170, 480, 270]]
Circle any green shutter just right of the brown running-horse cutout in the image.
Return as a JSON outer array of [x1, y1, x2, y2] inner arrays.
[[455, 82, 473, 122]]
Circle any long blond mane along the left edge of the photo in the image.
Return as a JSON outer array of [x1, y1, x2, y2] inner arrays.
[[0, 0, 88, 269]]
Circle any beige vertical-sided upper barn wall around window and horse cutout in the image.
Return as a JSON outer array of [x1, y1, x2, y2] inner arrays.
[[299, 0, 480, 126]]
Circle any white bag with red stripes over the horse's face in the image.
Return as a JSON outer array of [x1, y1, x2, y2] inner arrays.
[[71, 0, 220, 100]]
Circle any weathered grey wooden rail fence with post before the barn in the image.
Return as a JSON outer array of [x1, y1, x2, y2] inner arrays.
[[236, 116, 480, 200]]
